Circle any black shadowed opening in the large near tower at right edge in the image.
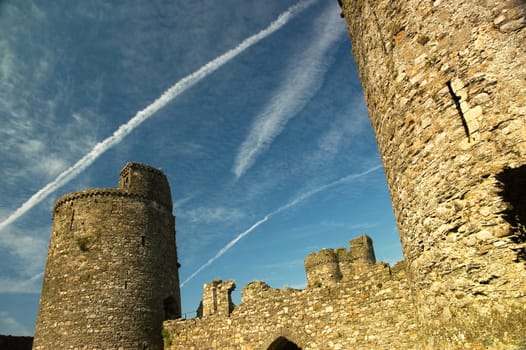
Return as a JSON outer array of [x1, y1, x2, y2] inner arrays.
[[497, 164, 526, 261]]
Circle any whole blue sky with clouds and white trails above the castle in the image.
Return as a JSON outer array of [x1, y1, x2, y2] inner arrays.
[[0, 0, 402, 335]]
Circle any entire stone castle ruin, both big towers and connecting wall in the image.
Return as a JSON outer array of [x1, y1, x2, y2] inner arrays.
[[34, 0, 526, 350]]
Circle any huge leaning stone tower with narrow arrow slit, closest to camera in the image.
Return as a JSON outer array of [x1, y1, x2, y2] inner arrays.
[[340, 0, 526, 348]]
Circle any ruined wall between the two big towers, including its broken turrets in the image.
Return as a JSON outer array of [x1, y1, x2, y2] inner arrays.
[[164, 235, 418, 350]]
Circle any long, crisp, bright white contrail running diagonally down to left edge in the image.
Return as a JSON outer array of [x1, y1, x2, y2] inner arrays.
[[0, 0, 315, 235]]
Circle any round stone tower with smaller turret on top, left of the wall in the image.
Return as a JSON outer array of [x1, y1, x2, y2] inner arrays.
[[33, 163, 181, 350]]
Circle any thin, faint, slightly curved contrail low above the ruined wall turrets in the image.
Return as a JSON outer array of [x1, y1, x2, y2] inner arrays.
[[181, 165, 382, 288]]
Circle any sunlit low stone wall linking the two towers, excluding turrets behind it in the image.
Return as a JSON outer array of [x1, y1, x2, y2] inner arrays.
[[164, 263, 416, 350]]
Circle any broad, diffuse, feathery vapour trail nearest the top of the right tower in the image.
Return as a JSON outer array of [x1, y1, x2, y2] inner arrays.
[[232, 0, 345, 178]]
